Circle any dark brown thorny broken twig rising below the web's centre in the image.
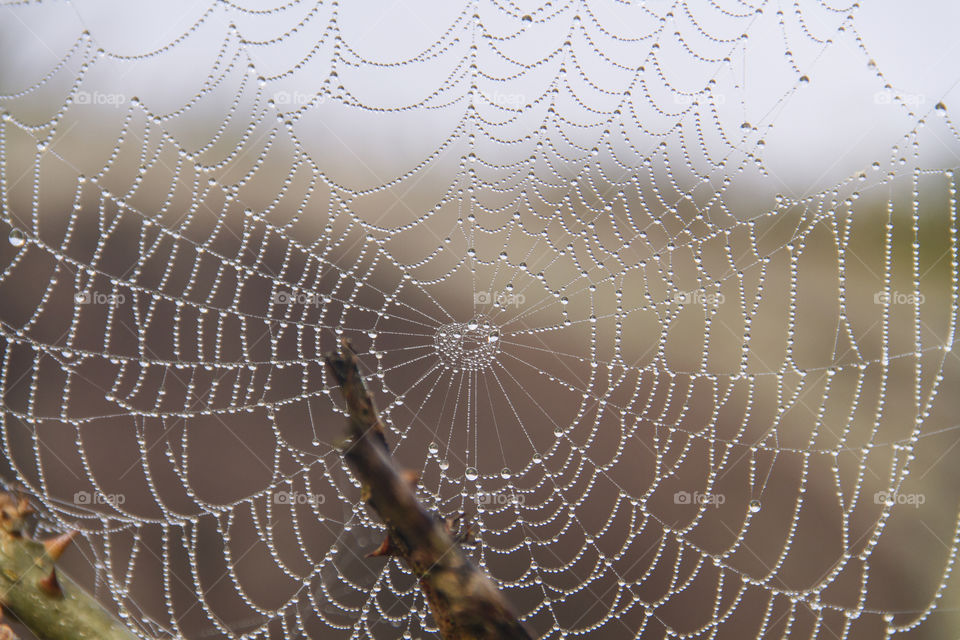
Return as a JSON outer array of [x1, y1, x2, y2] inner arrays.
[[326, 339, 530, 640]]
